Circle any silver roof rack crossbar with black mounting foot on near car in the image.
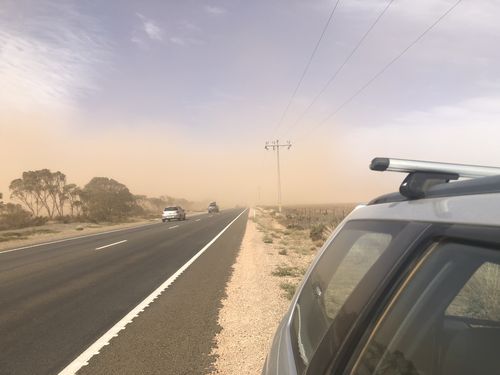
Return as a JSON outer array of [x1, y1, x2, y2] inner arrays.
[[370, 158, 500, 199]]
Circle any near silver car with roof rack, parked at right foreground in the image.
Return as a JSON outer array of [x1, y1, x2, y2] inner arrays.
[[263, 158, 500, 375]]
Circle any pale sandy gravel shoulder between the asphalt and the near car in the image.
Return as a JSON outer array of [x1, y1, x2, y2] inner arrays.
[[212, 209, 317, 375]]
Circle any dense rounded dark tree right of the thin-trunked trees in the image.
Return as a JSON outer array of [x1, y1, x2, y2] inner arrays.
[[81, 177, 137, 221]]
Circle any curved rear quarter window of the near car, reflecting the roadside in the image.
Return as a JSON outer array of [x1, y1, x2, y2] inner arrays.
[[292, 222, 404, 368]]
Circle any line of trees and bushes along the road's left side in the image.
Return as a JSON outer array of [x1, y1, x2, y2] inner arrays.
[[0, 169, 202, 230]]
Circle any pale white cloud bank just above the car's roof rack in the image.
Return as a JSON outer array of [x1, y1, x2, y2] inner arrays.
[[336, 96, 500, 170]]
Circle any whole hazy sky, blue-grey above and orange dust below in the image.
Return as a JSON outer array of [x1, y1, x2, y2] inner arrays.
[[0, 0, 500, 205]]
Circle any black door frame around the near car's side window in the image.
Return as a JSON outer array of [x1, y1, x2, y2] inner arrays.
[[336, 223, 500, 374]]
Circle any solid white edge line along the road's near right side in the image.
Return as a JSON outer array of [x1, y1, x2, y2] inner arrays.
[[58, 208, 247, 375]]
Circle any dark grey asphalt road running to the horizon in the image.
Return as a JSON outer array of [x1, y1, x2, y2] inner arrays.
[[0, 209, 246, 374]]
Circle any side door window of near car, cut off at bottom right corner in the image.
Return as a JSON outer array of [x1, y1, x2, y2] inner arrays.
[[351, 242, 500, 375]]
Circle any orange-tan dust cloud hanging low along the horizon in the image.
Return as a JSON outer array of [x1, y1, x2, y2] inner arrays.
[[0, 114, 390, 206]]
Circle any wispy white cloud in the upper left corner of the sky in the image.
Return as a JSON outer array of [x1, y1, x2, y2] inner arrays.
[[0, 2, 109, 111]]
